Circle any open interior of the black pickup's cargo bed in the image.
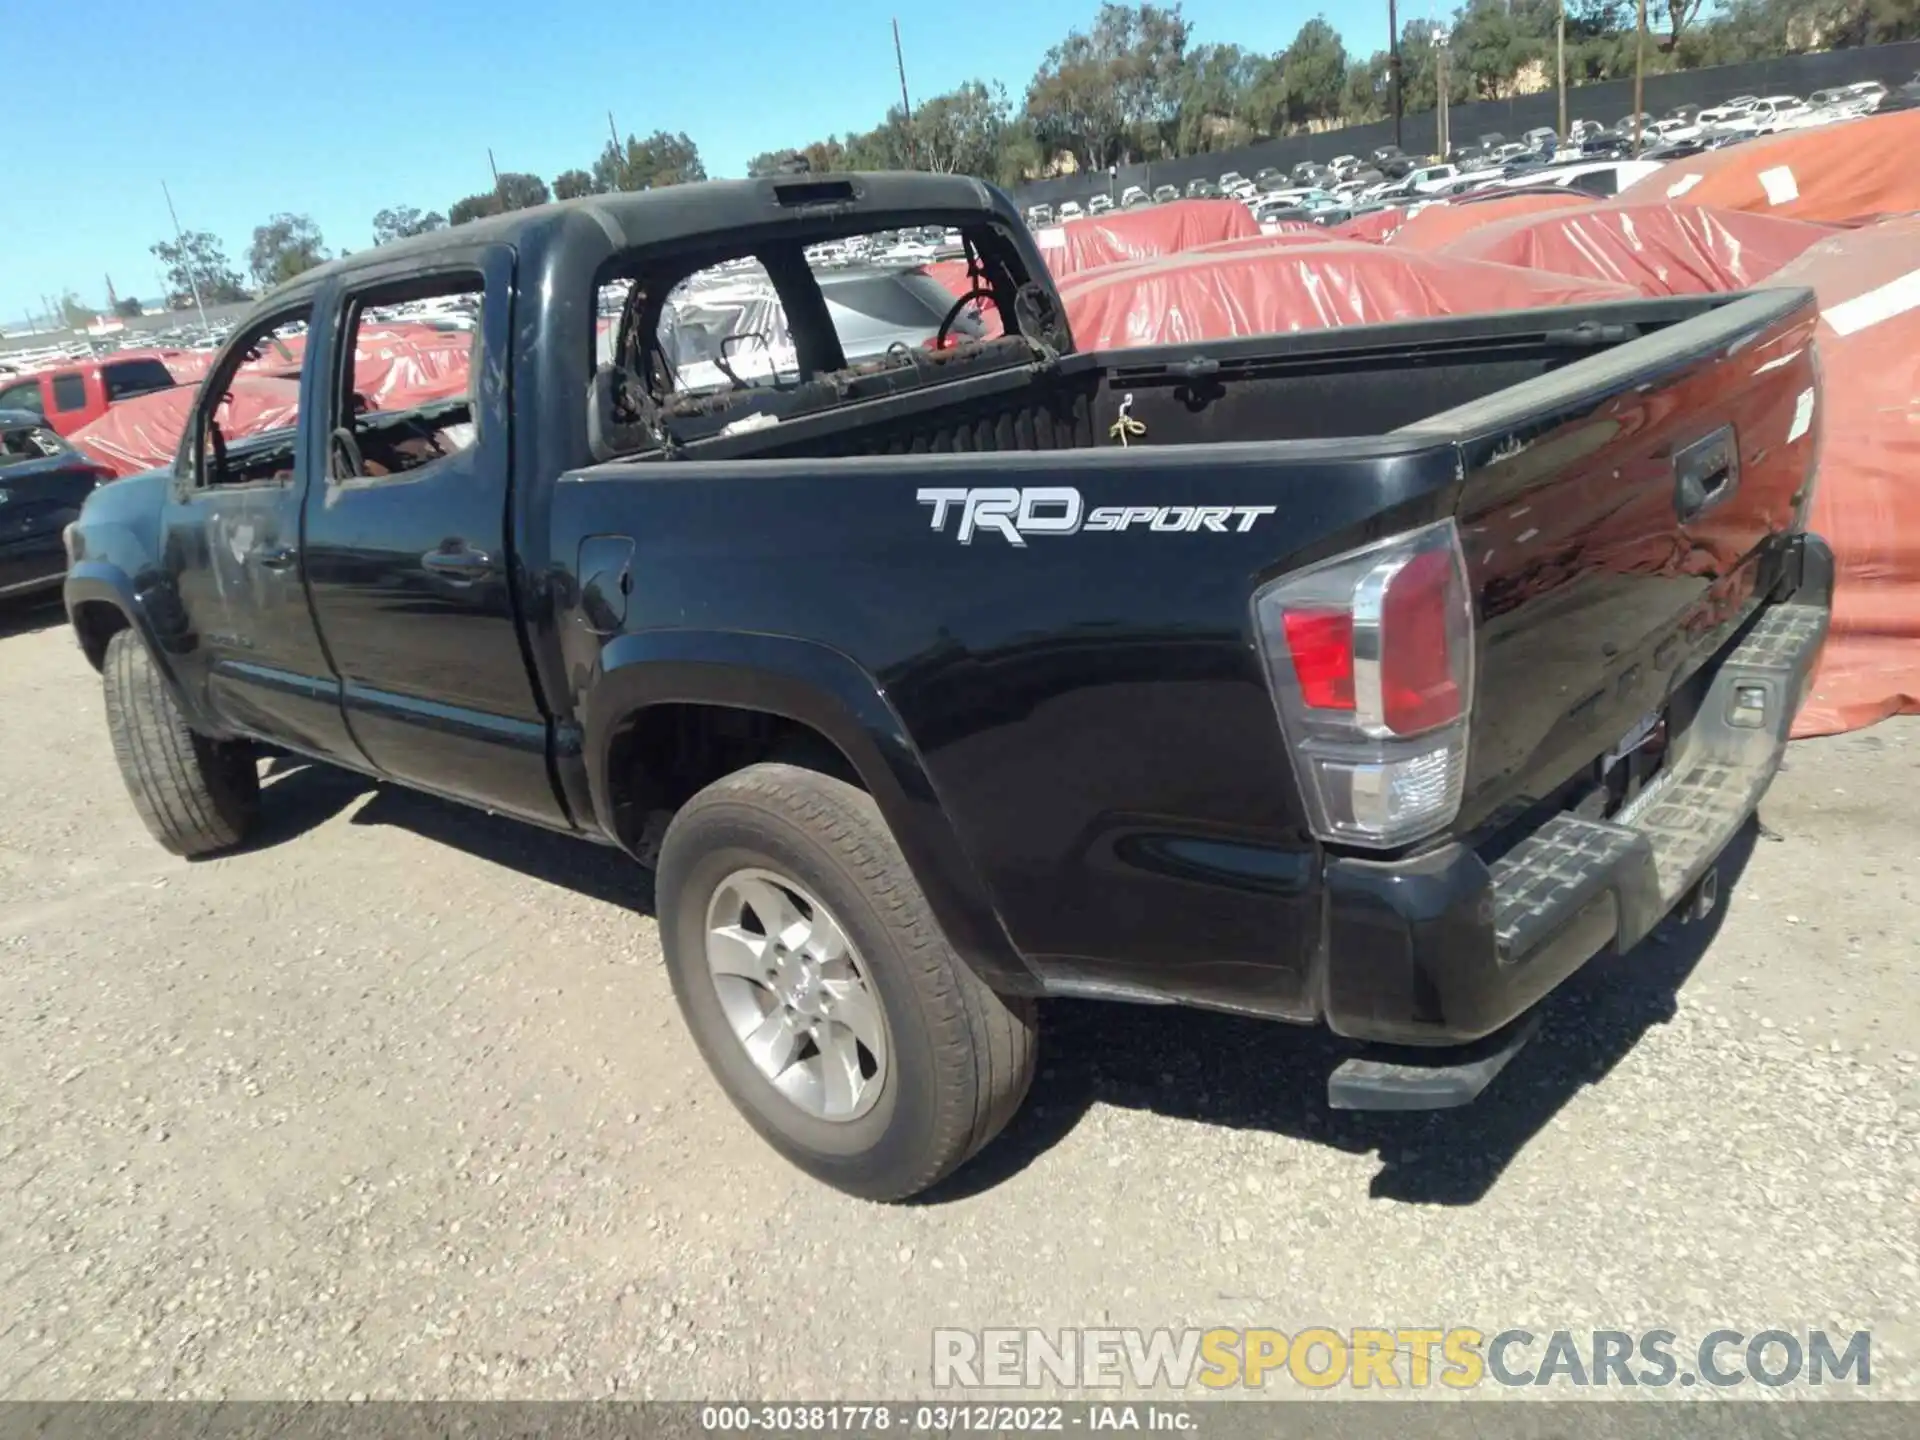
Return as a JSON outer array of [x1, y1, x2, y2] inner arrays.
[[622, 296, 1730, 461]]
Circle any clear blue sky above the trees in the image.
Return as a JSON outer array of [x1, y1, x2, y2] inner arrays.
[[0, 0, 1382, 324]]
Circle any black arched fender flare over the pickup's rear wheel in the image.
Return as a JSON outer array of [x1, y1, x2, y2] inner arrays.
[[580, 630, 1041, 993]]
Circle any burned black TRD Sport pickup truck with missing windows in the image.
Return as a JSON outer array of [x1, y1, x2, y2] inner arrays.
[[65, 175, 1834, 1198]]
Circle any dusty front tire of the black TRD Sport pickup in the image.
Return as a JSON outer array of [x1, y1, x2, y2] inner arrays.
[[102, 630, 259, 858]]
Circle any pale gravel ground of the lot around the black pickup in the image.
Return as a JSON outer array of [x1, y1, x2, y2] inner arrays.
[[0, 599, 1920, 1400]]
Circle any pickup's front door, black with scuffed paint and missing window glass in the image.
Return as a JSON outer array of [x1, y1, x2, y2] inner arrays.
[[159, 301, 363, 764]]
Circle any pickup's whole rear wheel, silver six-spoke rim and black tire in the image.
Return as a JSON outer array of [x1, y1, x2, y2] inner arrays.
[[657, 764, 1035, 1200]]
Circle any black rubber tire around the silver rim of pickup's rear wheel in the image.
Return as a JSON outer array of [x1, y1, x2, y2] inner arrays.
[[657, 764, 1035, 1200]]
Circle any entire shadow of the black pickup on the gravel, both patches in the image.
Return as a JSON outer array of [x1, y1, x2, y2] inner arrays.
[[248, 756, 1761, 1206]]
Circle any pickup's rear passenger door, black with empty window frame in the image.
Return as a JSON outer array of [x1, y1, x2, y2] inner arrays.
[[305, 246, 570, 828]]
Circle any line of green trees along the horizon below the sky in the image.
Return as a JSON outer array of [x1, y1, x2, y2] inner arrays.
[[131, 0, 1920, 305]]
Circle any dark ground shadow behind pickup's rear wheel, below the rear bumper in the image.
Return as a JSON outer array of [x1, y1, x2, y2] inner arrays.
[[922, 820, 1759, 1206]]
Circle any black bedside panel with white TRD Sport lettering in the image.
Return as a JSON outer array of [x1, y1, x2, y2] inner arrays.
[[553, 442, 1455, 1018]]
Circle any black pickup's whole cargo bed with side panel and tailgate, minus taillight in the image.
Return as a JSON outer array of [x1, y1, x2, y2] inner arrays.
[[553, 292, 1816, 1033]]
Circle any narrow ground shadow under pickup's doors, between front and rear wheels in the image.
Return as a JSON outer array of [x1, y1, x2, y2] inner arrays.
[[246, 755, 653, 916]]
